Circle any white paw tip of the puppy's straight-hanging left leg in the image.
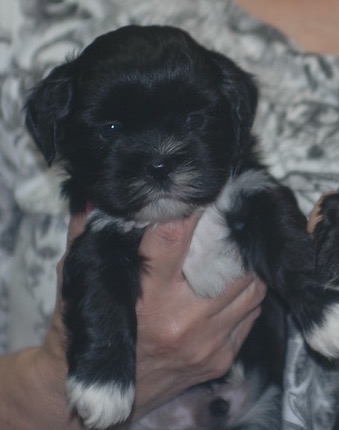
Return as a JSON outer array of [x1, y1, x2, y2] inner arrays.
[[67, 378, 134, 429]]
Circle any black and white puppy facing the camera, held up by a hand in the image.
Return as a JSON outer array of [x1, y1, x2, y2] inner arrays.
[[26, 26, 339, 429]]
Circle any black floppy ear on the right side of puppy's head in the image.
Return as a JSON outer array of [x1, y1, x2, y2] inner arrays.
[[212, 52, 258, 143]]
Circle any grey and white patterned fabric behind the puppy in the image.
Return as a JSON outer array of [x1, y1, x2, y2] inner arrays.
[[0, 0, 339, 430]]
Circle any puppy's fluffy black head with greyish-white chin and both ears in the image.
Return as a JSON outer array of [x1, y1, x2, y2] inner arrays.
[[26, 26, 257, 222]]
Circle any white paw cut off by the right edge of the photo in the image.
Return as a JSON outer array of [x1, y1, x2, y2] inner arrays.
[[305, 304, 339, 358]]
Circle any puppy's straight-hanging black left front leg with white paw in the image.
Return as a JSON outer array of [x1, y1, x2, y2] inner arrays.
[[62, 223, 142, 429]]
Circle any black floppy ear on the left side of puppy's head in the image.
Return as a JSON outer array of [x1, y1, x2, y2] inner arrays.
[[25, 64, 73, 165]]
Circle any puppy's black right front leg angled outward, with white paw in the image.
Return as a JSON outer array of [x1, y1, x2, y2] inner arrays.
[[226, 175, 339, 357]]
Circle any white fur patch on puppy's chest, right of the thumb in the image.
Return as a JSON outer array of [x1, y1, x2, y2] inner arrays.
[[183, 204, 245, 297]]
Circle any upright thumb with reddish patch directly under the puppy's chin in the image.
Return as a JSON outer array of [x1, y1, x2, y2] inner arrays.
[[140, 215, 199, 286]]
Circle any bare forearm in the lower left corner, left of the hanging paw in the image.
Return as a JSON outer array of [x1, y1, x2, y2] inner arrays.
[[0, 348, 81, 430]]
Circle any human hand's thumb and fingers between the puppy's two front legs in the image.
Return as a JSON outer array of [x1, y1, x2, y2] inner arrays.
[[133, 217, 266, 419]]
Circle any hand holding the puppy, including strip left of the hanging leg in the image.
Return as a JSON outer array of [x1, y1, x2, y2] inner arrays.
[[16, 216, 266, 430]]
